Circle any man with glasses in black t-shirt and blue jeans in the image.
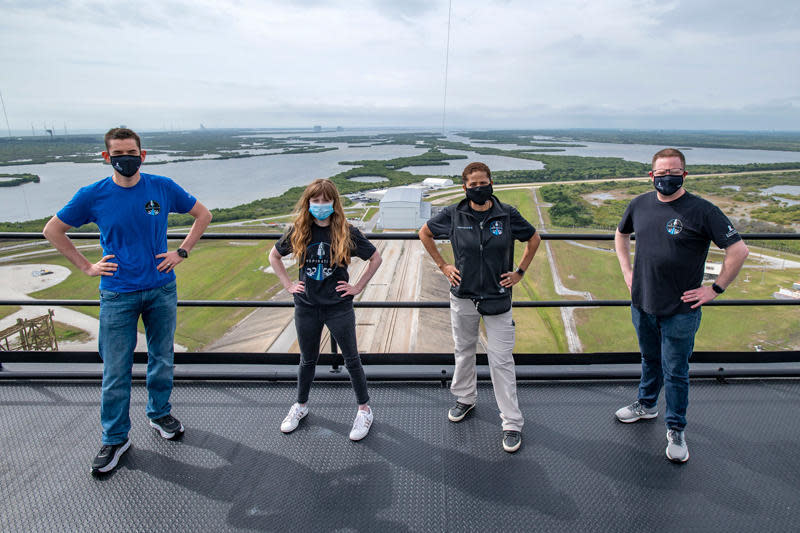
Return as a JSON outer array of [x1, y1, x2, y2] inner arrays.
[[614, 148, 749, 463]]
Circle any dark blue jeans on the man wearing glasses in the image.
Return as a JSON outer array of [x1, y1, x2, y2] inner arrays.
[[631, 306, 702, 431]]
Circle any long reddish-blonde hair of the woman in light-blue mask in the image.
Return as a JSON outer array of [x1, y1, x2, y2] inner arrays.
[[291, 179, 352, 266]]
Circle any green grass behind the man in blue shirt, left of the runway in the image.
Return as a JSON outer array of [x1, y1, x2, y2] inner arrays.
[[31, 241, 290, 350]]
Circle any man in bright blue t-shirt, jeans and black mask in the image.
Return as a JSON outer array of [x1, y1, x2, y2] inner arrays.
[[44, 128, 211, 474]]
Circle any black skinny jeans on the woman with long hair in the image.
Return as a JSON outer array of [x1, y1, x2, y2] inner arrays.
[[294, 302, 369, 405]]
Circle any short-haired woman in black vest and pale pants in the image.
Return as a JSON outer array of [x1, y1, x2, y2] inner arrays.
[[419, 162, 541, 452]]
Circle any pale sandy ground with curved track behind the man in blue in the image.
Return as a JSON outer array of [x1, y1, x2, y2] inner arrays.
[[0, 263, 186, 352]]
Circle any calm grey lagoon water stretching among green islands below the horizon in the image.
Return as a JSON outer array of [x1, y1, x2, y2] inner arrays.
[[0, 135, 800, 221]]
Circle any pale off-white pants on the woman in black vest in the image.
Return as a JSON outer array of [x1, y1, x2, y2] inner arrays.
[[450, 293, 524, 431]]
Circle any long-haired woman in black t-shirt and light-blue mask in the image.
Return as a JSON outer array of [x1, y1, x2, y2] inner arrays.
[[269, 179, 381, 440]]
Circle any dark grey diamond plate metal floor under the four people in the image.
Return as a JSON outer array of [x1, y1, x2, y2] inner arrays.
[[0, 380, 800, 532]]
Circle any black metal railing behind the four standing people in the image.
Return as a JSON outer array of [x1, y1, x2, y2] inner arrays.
[[0, 232, 800, 382]]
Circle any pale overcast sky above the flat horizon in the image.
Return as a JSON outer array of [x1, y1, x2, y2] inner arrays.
[[0, 0, 800, 132]]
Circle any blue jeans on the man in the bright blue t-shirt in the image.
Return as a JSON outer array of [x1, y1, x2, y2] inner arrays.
[[99, 281, 178, 444]]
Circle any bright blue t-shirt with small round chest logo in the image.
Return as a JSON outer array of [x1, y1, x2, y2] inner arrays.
[[56, 173, 197, 292]]
